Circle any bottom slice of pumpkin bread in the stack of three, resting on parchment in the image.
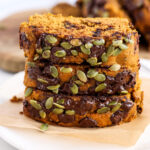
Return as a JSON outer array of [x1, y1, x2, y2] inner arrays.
[[23, 89, 143, 127]]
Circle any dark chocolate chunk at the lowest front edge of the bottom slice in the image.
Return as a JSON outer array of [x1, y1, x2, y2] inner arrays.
[[79, 117, 97, 128]]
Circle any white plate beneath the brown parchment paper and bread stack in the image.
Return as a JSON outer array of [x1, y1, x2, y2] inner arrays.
[[0, 72, 150, 150]]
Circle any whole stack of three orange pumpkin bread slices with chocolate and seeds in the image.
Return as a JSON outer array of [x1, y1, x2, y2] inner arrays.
[[20, 14, 143, 127]]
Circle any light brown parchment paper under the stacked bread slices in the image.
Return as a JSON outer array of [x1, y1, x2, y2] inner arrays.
[[0, 79, 150, 146]]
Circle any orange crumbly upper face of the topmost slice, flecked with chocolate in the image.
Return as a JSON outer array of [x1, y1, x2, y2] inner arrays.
[[21, 13, 137, 39]]
